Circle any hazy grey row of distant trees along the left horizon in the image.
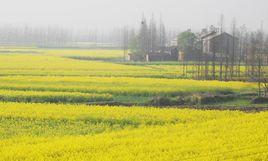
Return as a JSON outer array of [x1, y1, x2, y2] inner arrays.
[[0, 25, 126, 48]]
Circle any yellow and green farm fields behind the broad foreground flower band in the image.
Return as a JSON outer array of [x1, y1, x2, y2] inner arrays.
[[0, 47, 266, 106]]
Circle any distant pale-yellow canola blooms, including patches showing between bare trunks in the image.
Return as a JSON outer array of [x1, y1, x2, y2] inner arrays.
[[0, 47, 268, 78]]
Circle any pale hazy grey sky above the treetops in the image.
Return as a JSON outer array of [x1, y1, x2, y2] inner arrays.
[[0, 0, 268, 30]]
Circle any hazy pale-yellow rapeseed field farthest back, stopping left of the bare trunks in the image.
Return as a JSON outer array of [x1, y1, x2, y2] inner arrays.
[[0, 50, 181, 77]]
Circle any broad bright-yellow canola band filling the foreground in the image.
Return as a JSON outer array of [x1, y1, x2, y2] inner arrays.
[[0, 103, 268, 161]]
